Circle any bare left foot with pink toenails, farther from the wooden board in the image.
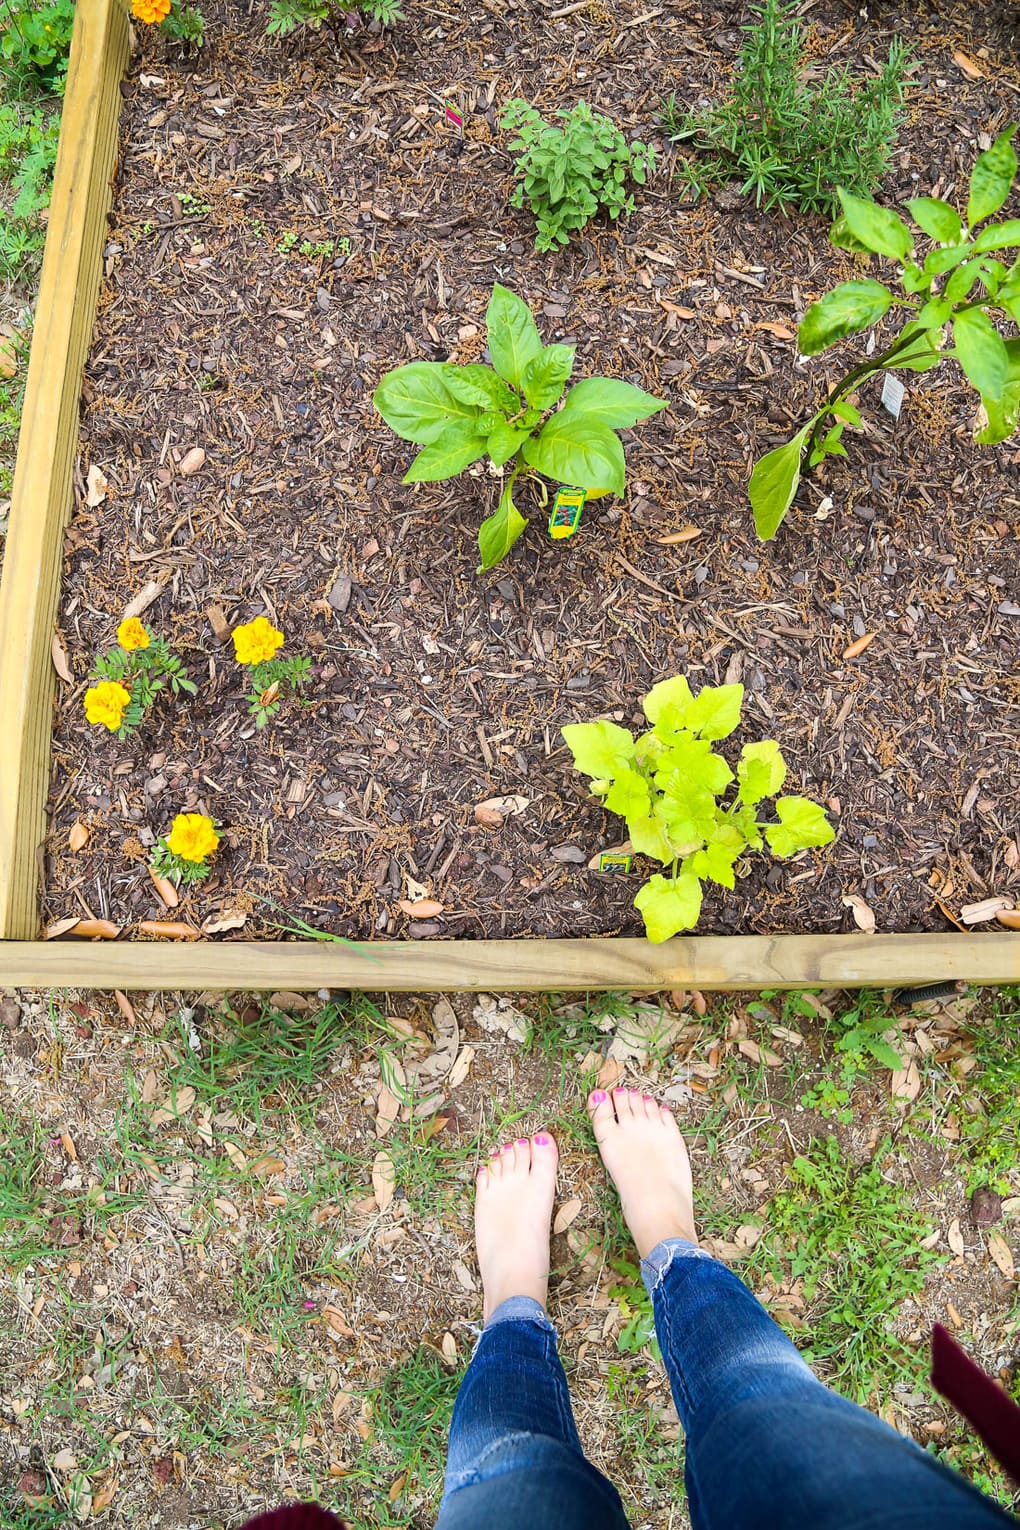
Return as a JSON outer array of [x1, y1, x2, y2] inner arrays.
[[474, 1132, 558, 1319]]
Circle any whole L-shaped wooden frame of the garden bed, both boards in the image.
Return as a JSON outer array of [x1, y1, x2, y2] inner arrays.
[[0, 0, 1020, 993]]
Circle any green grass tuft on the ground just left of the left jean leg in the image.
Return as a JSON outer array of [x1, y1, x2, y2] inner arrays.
[[356, 1346, 463, 1530]]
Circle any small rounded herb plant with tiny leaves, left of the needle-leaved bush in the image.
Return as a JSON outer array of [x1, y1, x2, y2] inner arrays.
[[500, 98, 655, 249]]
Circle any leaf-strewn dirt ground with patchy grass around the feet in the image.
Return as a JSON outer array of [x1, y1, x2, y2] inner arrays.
[[0, 993, 1020, 1530]]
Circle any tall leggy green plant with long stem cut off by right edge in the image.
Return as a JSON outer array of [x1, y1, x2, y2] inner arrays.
[[749, 124, 1020, 540]]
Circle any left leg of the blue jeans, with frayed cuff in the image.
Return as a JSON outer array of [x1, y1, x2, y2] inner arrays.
[[437, 1296, 627, 1530]]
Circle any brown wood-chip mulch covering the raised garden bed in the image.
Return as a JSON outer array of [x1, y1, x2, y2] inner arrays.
[[43, 0, 1020, 936]]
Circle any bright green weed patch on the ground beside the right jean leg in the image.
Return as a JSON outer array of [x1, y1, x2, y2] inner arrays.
[[743, 1137, 940, 1401]]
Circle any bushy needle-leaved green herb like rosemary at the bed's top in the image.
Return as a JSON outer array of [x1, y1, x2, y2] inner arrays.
[[665, 0, 907, 213]]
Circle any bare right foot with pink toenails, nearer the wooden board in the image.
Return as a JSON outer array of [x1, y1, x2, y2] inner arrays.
[[587, 1089, 697, 1259]]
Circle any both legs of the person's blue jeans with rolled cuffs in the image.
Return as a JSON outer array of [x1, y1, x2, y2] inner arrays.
[[437, 1238, 1017, 1530]]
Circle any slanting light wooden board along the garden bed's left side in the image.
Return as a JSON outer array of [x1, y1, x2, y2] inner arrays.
[[0, 0, 128, 939]]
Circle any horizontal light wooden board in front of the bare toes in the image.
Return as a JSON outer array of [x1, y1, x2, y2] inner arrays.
[[0, 932, 1020, 993]]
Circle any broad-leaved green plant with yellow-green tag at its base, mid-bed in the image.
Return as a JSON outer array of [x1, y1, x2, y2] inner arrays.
[[373, 282, 667, 572]]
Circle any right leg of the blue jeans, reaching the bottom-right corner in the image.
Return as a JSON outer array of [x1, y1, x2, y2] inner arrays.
[[642, 1238, 1017, 1530]]
